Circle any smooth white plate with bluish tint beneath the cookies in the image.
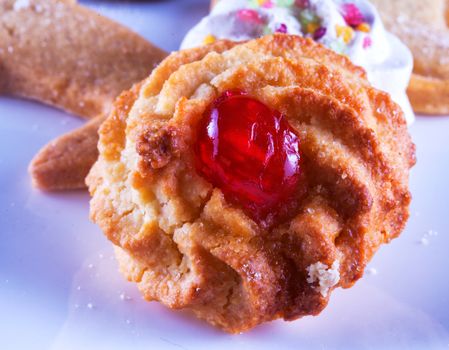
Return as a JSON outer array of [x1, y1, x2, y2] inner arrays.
[[0, 0, 449, 350]]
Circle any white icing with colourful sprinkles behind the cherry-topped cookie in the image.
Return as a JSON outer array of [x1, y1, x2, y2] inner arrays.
[[181, 0, 414, 124]]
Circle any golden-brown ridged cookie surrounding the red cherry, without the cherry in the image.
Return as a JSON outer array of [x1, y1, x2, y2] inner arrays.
[[87, 34, 415, 333]]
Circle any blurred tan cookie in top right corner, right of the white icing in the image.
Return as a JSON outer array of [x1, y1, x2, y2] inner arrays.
[[371, 0, 449, 114]]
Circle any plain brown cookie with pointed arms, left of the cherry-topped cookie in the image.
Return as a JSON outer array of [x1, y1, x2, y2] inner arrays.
[[0, 0, 167, 190]]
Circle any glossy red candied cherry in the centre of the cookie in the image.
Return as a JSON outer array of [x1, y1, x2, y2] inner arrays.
[[195, 91, 301, 224]]
